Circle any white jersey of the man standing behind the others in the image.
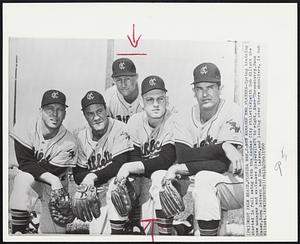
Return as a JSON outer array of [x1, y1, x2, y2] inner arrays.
[[104, 85, 143, 123]]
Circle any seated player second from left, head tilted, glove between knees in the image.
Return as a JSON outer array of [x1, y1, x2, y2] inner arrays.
[[73, 91, 133, 234]]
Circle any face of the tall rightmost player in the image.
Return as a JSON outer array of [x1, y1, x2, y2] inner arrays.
[[193, 82, 220, 110]]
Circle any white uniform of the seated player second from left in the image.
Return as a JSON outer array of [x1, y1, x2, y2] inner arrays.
[[77, 118, 133, 234]]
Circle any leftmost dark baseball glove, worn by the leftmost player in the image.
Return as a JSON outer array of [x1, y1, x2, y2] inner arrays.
[[48, 188, 75, 227]]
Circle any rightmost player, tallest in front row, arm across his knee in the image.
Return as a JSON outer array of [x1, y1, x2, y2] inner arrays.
[[166, 63, 244, 236]]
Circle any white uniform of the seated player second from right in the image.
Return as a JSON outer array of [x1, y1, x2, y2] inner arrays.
[[108, 111, 174, 232]]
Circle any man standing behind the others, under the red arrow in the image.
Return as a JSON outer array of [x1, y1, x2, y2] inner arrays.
[[104, 58, 142, 123]]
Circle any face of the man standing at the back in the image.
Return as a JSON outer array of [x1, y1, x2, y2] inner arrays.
[[114, 75, 137, 97]]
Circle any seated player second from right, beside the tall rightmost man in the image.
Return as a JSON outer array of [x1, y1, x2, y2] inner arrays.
[[108, 75, 192, 235]]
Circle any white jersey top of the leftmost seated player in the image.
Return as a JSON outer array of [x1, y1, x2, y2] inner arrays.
[[11, 118, 77, 167]]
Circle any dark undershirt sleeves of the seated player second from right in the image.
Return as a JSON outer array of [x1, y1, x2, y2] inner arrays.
[[129, 144, 176, 178]]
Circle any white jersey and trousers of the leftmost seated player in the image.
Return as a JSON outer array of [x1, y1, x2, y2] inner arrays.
[[10, 118, 77, 234]]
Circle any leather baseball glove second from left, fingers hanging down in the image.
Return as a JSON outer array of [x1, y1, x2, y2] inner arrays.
[[72, 184, 101, 222]]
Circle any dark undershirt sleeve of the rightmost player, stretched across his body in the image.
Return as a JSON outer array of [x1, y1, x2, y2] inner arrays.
[[175, 143, 230, 175]]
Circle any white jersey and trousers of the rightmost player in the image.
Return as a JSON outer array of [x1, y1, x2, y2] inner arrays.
[[174, 99, 244, 221]]
